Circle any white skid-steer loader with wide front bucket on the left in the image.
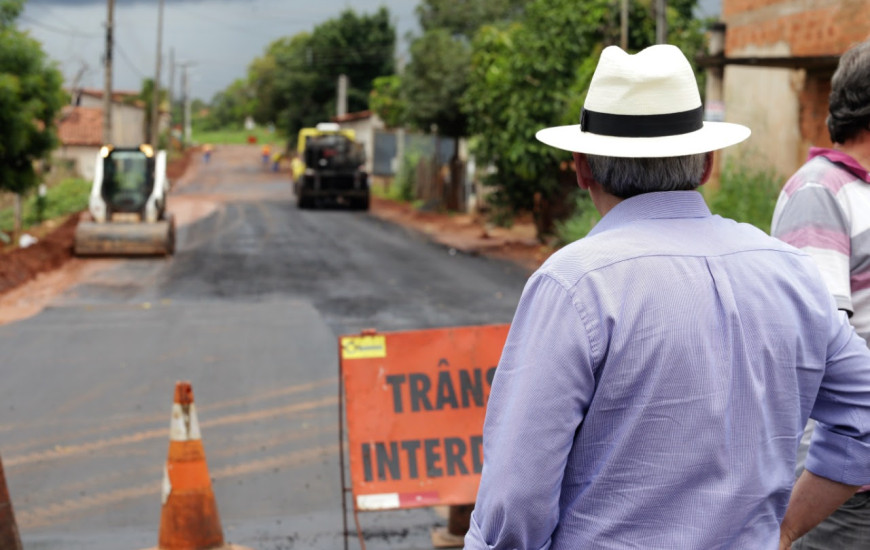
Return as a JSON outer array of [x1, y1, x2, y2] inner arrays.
[[74, 145, 175, 256]]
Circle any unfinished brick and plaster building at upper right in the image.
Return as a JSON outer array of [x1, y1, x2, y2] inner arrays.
[[708, 0, 870, 177]]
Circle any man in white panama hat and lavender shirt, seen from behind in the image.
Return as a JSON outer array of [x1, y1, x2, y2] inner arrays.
[[465, 45, 870, 550]]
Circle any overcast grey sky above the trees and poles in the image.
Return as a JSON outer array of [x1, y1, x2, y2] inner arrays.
[[18, 0, 720, 101]]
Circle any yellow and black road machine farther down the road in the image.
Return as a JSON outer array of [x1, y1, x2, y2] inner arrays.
[[292, 122, 369, 210]]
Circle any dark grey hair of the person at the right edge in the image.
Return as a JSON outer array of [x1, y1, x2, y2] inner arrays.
[[826, 40, 870, 143]]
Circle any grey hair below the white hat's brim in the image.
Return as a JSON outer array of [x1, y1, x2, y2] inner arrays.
[[586, 153, 706, 199]]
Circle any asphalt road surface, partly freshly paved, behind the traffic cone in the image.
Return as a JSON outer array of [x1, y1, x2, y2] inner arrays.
[[0, 147, 528, 550]]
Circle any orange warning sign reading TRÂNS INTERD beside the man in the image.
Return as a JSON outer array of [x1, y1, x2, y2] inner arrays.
[[339, 325, 510, 510]]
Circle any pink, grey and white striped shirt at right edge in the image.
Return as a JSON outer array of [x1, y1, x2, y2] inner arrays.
[[771, 147, 870, 340]]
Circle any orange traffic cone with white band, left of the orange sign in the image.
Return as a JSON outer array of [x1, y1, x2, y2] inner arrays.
[[145, 382, 250, 550]]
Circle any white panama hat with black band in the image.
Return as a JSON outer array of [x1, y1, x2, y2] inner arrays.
[[535, 44, 750, 158]]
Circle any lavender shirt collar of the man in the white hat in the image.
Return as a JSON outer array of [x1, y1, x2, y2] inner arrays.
[[589, 191, 711, 236]]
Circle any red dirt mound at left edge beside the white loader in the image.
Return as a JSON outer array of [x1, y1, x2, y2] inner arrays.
[[0, 214, 79, 293]]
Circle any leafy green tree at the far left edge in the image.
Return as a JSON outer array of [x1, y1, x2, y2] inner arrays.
[[0, 0, 64, 193]]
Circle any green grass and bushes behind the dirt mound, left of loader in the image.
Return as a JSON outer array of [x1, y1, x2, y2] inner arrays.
[[0, 178, 91, 232]]
